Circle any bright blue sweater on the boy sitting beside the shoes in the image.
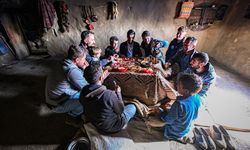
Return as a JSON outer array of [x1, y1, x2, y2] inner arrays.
[[160, 94, 201, 139]]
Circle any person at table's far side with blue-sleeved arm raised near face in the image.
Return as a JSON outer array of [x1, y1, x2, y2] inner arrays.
[[141, 31, 168, 64]]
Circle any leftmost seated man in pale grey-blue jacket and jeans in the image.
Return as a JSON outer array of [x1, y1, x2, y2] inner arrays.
[[46, 45, 88, 117]]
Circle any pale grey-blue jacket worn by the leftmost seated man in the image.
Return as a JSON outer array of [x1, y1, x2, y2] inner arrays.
[[46, 59, 88, 105]]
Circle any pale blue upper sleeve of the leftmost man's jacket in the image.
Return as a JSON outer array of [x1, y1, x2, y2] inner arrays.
[[67, 68, 88, 90]]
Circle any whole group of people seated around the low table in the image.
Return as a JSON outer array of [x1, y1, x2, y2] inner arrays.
[[46, 26, 216, 142]]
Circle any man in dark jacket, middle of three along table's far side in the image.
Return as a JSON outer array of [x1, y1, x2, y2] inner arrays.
[[120, 29, 142, 57]]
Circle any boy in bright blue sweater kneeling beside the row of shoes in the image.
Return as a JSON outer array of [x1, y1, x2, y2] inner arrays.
[[149, 73, 202, 143]]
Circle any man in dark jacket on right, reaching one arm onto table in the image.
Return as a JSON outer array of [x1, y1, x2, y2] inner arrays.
[[165, 37, 198, 72]]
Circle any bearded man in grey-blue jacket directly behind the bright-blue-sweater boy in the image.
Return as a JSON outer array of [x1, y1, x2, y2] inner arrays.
[[184, 52, 216, 98]]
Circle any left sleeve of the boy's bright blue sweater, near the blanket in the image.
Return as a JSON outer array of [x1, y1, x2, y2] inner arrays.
[[160, 102, 180, 124]]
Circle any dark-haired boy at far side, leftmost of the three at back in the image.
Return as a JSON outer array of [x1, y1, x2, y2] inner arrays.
[[105, 36, 120, 59]]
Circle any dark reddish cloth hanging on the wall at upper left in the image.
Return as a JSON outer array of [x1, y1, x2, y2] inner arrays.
[[38, 0, 55, 32]]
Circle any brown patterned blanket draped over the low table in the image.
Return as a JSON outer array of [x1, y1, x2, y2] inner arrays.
[[104, 71, 177, 106]]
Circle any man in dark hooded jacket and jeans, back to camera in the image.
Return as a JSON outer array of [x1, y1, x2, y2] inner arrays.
[[80, 63, 136, 133]]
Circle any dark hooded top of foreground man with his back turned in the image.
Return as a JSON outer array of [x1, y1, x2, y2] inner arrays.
[[80, 84, 125, 133]]
